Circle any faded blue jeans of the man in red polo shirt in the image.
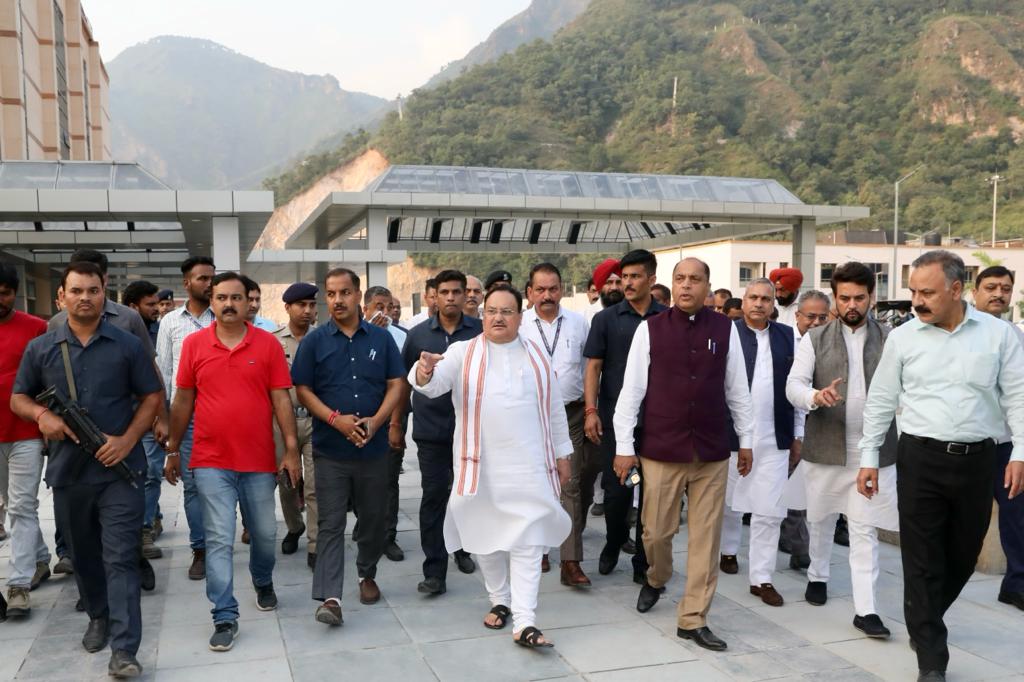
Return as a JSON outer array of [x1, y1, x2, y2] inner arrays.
[[193, 467, 278, 623]]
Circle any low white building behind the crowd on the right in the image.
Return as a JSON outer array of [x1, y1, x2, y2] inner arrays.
[[655, 240, 1024, 319]]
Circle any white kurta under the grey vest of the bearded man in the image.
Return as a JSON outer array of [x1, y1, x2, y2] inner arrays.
[[786, 325, 899, 530]]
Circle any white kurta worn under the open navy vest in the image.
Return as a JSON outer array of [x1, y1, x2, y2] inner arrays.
[[727, 328, 803, 518]]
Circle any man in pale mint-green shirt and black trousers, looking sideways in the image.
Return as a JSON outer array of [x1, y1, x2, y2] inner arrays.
[[851, 250, 1024, 681]]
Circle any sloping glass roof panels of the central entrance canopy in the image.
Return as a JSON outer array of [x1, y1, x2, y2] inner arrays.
[[364, 166, 803, 204]]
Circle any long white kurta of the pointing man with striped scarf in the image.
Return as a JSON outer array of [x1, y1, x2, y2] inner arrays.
[[410, 333, 572, 554]]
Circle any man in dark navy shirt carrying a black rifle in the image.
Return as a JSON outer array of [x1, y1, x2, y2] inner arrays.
[[10, 262, 162, 677]]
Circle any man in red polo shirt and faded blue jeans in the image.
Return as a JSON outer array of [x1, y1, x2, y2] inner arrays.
[[165, 272, 301, 651]]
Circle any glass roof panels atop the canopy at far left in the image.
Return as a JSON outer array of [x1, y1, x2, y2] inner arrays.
[[0, 161, 170, 189]]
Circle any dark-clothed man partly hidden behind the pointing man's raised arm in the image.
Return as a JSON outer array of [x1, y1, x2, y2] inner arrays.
[[395, 270, 481, 595]]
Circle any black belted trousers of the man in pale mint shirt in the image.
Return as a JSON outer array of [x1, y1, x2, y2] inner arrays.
[[896, 434, 996, 671]]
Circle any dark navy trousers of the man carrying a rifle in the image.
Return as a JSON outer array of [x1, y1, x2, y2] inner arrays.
[[53, 479, 145, 654]]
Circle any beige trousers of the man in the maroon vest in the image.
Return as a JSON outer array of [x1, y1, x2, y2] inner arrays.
[[640, 457, 729, 630]]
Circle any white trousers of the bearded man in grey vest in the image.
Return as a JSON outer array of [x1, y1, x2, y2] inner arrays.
[[807, 514, 879, 615]]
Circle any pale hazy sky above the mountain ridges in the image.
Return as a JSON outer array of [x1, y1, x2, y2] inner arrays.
[[82, 0, 529, 99]]
